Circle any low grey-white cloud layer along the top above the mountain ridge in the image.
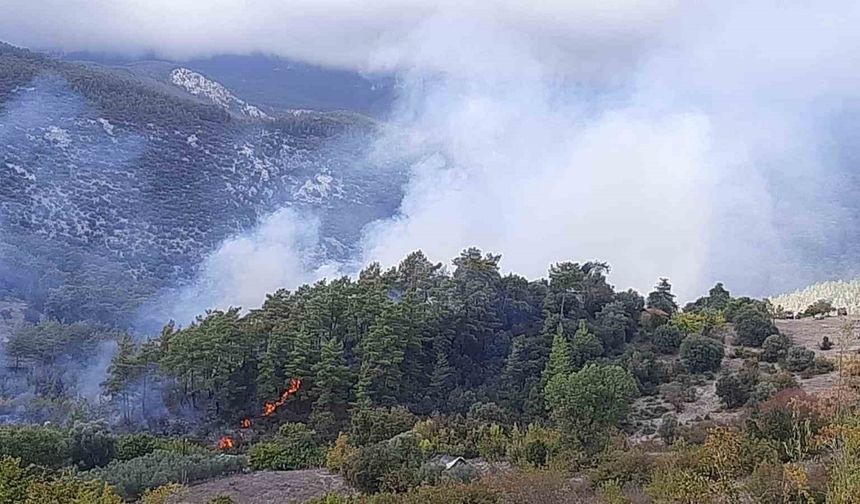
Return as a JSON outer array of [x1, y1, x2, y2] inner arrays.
[[0, 0, 678, 71]]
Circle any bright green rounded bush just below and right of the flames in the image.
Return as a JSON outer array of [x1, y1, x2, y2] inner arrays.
[[248, 423, 325, 471]]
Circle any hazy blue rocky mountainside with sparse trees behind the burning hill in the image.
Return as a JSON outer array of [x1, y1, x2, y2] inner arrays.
[[0, 44, 402, 324]]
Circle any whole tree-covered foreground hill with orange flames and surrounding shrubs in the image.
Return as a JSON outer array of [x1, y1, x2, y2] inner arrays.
[[0, 249, 860, 504]]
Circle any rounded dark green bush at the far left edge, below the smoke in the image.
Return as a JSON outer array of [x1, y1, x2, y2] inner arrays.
[[0, 426, 70, 468]]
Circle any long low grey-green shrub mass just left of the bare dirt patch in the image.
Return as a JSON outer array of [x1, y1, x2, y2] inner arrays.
[[83, 450, 246, 500]]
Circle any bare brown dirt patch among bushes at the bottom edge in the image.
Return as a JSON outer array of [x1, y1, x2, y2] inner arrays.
[[172, 469, 352, 504]]
